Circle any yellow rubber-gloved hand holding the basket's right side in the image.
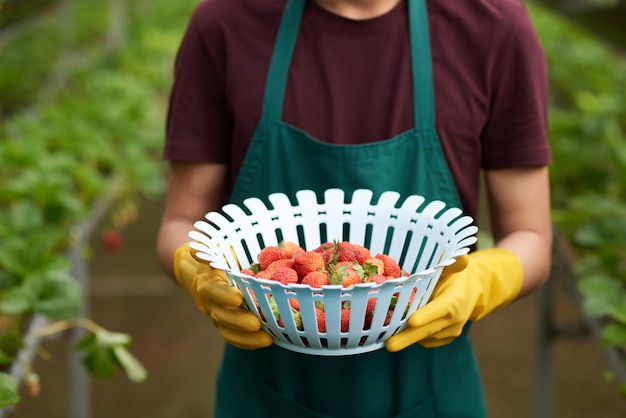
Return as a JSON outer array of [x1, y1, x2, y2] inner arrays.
[[386, 248, 524, 352]]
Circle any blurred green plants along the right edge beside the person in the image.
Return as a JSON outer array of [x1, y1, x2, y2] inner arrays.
[[529, 5, 626, 396]]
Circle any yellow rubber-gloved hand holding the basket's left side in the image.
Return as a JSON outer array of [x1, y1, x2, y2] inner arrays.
[[174, 244, 272, 350]]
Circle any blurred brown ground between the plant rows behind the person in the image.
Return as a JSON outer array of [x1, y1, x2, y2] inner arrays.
[[4, 201, 626, 418]]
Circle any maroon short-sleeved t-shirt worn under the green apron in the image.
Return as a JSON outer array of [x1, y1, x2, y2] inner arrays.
[[164, 0, 551, 222]]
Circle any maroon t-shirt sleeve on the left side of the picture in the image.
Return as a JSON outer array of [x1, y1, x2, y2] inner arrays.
[[164, 2, 232, 163]]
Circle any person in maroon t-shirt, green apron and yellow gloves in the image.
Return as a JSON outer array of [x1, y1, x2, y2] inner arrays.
[[157, 0, 551, 418]]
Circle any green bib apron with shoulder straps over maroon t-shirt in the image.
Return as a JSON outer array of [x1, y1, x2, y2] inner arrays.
[[215, 0, 486, 418]]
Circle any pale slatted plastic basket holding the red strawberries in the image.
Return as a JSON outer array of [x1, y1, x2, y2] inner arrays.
[[189, 189, 478, 355]]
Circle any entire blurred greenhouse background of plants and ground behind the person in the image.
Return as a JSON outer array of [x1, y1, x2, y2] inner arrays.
[[0, 0, 626, 418]]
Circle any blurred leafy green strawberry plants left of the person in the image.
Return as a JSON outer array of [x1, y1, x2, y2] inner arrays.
[[0, 0, 196, 407]]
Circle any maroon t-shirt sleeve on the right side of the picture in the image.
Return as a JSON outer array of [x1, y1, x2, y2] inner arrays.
[[482, 3, 551, 170]]
